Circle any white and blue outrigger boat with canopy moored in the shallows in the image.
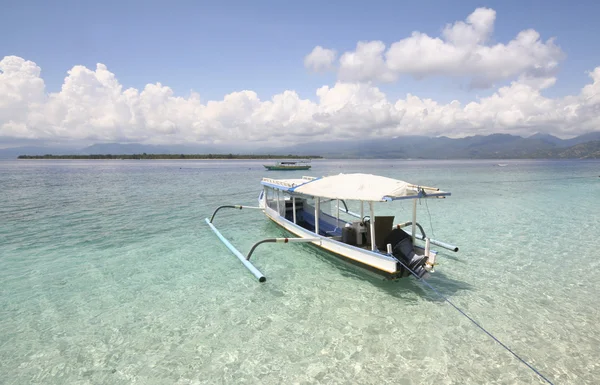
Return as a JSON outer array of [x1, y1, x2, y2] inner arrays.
[[206, 174, 458, 282]]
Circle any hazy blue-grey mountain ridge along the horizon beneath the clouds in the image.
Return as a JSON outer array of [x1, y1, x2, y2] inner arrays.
[[0, 132, 600, 159]]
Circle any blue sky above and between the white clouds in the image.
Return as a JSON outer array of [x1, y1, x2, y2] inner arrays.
[[0, 0, 600, 145]]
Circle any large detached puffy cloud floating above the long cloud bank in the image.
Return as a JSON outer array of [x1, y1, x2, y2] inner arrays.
[[313, 8, 565, 88]]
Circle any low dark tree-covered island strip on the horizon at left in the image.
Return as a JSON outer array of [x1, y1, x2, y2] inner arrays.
[[17, 153, 322, 160]]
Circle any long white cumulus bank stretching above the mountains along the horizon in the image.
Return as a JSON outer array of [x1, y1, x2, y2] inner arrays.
[[0, 53, 600, 144]]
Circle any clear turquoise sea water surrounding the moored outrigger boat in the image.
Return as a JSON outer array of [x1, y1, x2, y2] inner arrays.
[[0, 160, 600, 385]]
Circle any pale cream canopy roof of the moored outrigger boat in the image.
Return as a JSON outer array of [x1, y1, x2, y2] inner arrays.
[[261, 174, 450, 202]]
